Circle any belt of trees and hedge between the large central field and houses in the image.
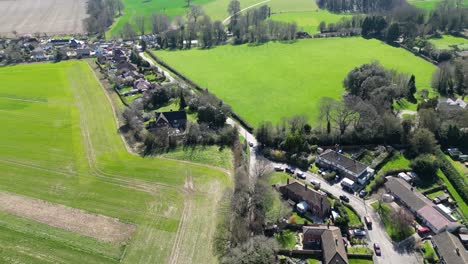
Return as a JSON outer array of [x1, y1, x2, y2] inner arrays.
[[255, 63, 422, 165]]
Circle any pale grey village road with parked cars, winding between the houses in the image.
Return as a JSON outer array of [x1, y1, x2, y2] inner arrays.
[[140, 53, 423, 264]]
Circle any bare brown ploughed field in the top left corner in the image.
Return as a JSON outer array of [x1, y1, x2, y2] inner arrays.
[[0, 0, 87, 35]]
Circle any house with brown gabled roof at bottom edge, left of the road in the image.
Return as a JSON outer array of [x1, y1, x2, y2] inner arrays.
[[302, 225, 348, 264]]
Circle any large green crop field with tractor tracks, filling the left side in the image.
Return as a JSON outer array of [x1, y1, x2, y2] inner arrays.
[[0, 62, 230, 263]]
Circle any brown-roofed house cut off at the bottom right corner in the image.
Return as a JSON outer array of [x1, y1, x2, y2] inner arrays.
[[432, 231, 468, 264]]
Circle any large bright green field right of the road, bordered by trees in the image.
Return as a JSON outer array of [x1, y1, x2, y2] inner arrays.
[[154, 37, 435, 126]]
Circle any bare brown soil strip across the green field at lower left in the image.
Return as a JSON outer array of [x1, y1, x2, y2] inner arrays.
[[0, 192, 135, 242]]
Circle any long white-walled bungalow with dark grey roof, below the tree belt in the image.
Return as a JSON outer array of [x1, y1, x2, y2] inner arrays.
[[316, 149, 374, 185]]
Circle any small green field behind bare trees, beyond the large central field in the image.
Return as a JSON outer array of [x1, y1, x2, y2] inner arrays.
[[271, 9, 351, 34]]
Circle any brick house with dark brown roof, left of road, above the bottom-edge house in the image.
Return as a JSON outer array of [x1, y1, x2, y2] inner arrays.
[[279, 179, 331, 218]]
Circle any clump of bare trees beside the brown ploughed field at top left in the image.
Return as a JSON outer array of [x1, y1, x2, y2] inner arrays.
[[85, 0, 124, 35]]
